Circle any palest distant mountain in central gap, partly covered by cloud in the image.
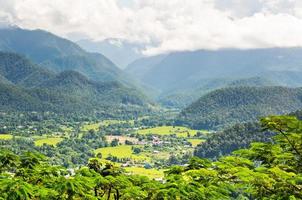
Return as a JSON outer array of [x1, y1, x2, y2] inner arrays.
[[77, 39, 144, 69]]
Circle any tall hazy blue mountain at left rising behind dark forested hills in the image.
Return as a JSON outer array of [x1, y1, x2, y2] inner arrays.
[[0, 28, 131, 83]]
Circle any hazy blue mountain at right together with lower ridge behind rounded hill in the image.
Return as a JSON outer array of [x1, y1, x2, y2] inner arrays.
[[126, 48, 302, 108]]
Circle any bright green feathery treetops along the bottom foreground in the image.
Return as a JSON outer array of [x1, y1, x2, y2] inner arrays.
[[0, 116, 302, 200]]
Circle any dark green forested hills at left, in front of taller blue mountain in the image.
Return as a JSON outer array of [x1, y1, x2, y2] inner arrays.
[[0, 53, 149, 116]]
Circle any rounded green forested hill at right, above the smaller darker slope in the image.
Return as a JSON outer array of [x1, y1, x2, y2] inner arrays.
[[177, 86, 302, 129]]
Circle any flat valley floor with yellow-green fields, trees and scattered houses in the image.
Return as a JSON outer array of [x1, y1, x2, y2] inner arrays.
[[0, 113, 209, 178]]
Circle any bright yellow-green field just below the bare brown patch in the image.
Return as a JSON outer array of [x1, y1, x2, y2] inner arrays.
[[94, 145, 149, 161]]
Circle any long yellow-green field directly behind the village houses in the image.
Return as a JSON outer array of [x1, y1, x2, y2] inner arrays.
[[137, 126, 198, 137]]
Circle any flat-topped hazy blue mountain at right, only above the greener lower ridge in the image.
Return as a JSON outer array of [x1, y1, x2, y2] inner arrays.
[[143, 48, 302, 89]]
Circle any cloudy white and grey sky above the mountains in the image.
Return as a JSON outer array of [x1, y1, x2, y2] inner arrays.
[[0, 0, 302, 55]]
